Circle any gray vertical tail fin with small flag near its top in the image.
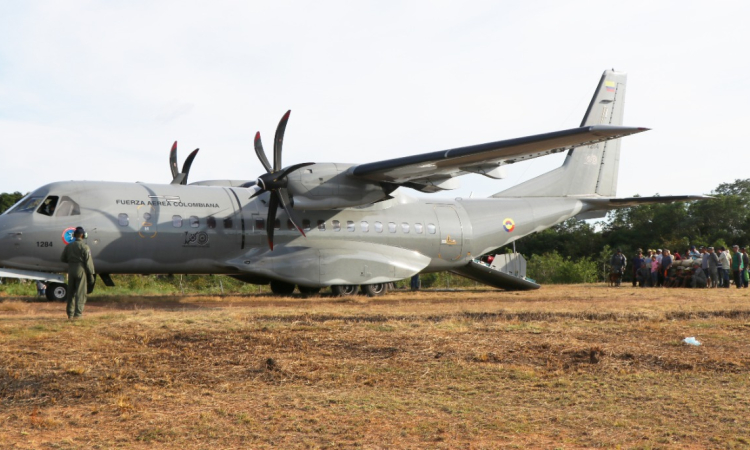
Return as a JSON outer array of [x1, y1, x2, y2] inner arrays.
[[493, 70, 627, 197]]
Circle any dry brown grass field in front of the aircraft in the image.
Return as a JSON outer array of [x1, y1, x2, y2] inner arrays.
[[0, 285, 750, 449]]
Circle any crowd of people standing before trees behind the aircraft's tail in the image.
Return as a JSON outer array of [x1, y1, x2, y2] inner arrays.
[[610, 245, 750, 289]]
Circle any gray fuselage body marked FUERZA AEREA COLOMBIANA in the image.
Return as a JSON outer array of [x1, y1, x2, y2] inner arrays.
[[0, 181, 583, 285]]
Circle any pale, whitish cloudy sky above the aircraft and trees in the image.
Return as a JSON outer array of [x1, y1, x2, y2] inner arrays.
[[0, 0, 750, 198]]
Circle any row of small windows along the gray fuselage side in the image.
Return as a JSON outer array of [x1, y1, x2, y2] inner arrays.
[[118, 213, 437, 234]]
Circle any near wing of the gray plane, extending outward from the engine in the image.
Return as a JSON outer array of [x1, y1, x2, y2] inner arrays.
[[350, 125, 648, 192]]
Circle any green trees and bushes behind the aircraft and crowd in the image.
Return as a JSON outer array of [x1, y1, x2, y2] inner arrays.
[[0, 179, 750, 285]]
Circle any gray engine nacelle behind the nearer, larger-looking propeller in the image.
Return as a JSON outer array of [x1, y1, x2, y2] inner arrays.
[[287, 163, 388, 210]]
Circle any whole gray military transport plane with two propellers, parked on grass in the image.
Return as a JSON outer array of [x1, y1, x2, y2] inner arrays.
[[0, 70, 704, 299]]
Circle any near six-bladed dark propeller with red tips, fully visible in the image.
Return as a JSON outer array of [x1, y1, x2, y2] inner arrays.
[[250, 111, 315, 250]]
